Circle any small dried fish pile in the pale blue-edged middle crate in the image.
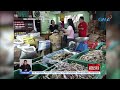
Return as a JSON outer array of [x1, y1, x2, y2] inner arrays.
[[52, 52, 73, 61]]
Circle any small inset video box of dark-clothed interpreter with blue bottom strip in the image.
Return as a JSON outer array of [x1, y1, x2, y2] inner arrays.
[[20, 59, 32, 74]]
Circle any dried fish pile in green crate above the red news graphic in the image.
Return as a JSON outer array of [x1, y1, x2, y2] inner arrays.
[[79, 50, 105, 63]]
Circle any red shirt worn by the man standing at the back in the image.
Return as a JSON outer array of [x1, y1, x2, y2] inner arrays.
[[78, 22, 87, 37]]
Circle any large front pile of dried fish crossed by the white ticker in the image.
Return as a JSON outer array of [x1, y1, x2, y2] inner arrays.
[[38, 62, 95, 79]]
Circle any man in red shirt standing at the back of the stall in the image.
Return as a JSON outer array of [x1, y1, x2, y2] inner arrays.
[[78, 17, 88, 37]]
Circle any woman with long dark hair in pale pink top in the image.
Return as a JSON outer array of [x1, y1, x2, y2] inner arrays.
[[62, 19, 75, 45]]
